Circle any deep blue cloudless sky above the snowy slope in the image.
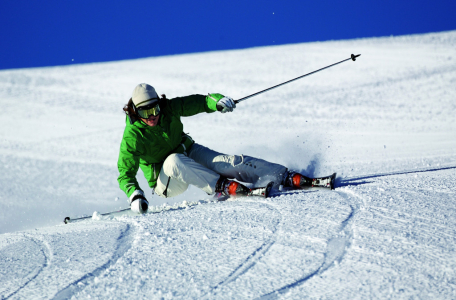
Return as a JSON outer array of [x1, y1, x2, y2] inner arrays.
[[0, 0, 456, 69]]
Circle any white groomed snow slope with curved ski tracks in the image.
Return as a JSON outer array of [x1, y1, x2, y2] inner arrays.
[[0, 31, 456, 299]]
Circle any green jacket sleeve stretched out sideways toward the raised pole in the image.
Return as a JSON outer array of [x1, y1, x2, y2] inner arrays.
[[169, 94, 224, 117]]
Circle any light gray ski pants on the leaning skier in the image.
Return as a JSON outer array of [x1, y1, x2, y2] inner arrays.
[[155, 144, 287, 198]]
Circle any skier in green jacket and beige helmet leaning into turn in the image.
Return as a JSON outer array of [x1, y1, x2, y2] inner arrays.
[[117, 83, 333, 213]]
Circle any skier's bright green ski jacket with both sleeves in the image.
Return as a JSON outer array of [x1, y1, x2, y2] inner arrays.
[[117, 94, 224, 197]]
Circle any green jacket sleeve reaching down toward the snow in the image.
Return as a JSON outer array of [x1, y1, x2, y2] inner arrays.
[[117, 129, 142, 197]]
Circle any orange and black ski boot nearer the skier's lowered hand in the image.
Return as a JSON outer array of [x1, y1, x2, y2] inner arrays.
[[215, 176, 274, 198]]
